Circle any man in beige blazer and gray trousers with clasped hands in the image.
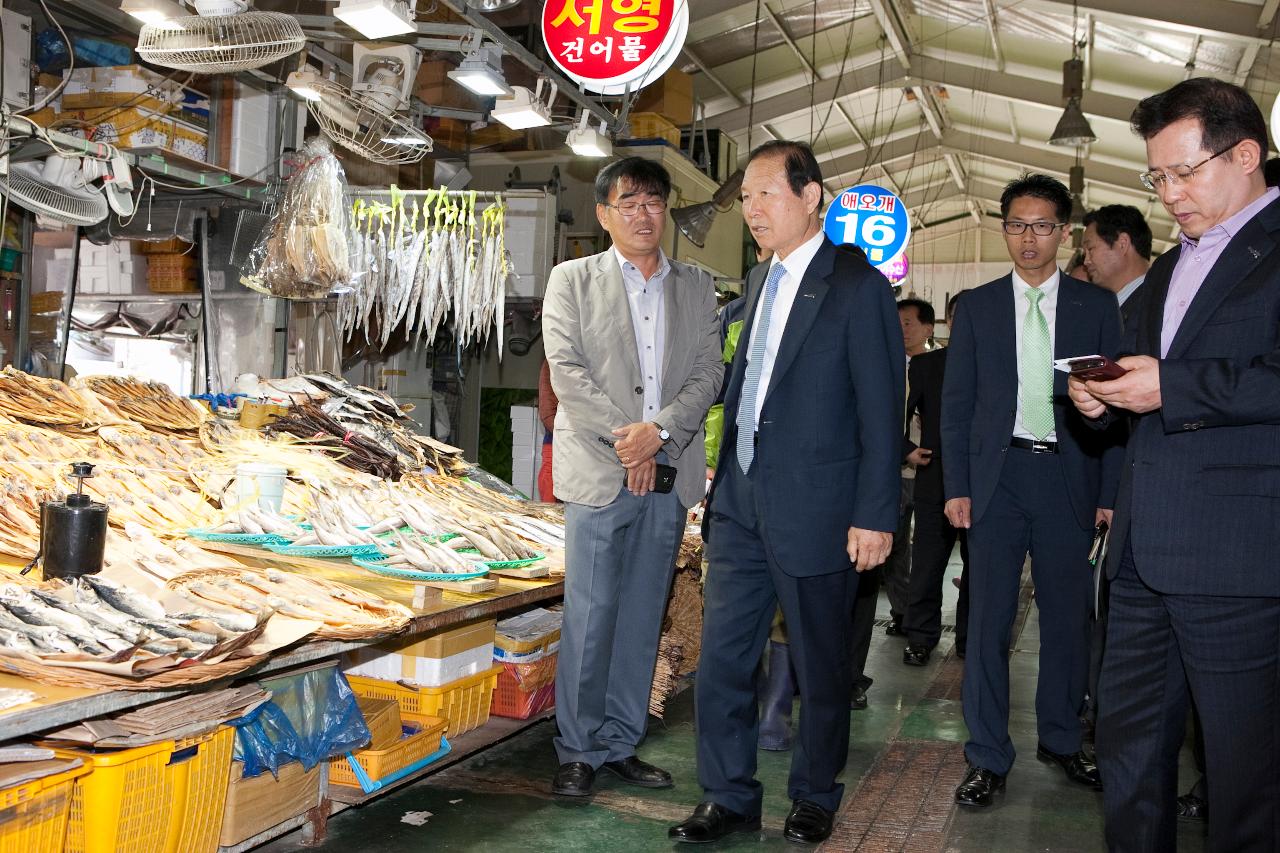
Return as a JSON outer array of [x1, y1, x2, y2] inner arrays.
[[543, 158, 723, 797]]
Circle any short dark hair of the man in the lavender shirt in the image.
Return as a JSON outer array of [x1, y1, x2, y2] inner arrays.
[[1129, 77, 1267, 156]]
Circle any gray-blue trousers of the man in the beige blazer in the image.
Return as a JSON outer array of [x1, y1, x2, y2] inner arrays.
[[556, 488, 685, 768]]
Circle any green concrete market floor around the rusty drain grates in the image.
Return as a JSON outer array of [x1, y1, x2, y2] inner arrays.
[[261, 558, 1204, 853]]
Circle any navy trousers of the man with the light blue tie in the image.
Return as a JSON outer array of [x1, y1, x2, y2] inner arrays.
[[694, 461, 858, 816]]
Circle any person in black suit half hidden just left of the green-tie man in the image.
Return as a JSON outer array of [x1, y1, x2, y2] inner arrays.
[[902, 293, 969, 666]]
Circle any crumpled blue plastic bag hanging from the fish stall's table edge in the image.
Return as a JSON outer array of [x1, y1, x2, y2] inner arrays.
[[230, 667, 371, 777]]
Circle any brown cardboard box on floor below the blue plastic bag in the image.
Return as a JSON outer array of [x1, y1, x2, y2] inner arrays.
[[218, 761, 320, 847]]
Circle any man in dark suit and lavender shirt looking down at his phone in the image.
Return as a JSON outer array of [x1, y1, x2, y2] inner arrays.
[[1071, 78, 1280, 853]]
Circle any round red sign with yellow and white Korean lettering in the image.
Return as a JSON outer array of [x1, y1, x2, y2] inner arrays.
[[543, 0, 689, 95]]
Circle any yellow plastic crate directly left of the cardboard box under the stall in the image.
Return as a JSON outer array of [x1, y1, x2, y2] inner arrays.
[[58, 726, 236, 853]]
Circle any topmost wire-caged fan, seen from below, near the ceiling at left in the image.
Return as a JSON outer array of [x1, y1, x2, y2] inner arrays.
[[138, 0, 307, 74]]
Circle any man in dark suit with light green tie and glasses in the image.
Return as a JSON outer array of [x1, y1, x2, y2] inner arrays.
[[942, 174, 1121, 807]]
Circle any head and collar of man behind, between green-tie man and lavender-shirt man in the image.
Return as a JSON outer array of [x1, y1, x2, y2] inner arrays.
[[1080, 205, 1151, 327]]
